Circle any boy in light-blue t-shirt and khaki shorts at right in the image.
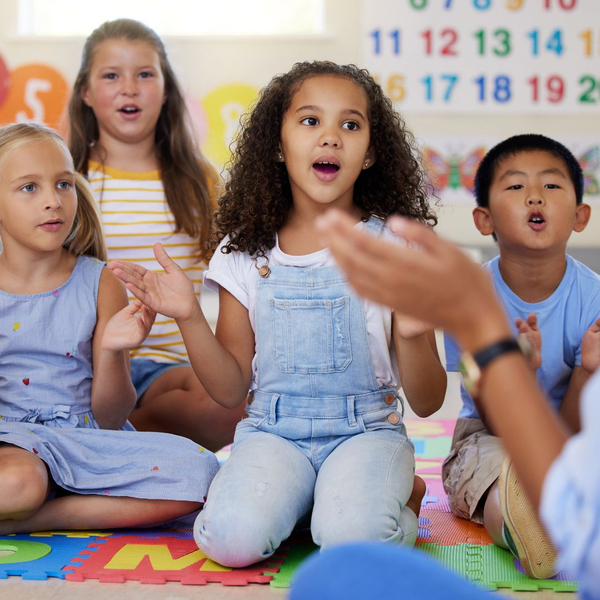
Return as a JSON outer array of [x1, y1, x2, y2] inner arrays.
[[442, 134, 600, 578]]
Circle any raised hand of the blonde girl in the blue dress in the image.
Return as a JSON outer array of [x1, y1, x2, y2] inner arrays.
[[102, 300, 156, 352]]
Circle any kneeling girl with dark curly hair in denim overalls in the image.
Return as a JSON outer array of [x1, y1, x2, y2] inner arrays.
[[111, 62, 446, 567]]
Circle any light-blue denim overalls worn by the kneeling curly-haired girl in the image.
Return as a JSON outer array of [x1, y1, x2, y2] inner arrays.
[[194, 218, 418, 567]]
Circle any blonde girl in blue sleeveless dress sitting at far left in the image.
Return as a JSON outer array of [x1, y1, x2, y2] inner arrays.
[[0, 124, 218, 534]]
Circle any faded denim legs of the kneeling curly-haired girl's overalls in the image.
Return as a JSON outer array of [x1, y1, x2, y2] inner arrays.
[[194, 419, 418, 567]]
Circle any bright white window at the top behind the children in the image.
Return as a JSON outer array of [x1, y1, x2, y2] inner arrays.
[[19, 0, 325, 37]]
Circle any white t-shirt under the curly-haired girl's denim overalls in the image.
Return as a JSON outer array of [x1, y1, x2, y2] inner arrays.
[[204, 221, 399, 389]]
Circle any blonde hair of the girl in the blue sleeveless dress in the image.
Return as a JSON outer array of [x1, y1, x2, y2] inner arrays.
[[0, 123, 106, 260]]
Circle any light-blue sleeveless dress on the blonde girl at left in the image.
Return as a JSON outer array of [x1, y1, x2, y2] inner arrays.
[[0, 256, 218, 501]]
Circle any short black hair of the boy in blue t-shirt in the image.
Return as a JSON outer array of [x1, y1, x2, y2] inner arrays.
[[475, 133, 583, 208]]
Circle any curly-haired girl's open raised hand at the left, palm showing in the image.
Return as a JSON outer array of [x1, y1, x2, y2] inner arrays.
[[108, 243, 200, 320]]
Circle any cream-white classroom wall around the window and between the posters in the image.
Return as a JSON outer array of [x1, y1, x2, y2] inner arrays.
[[0, 0, 600, 247]]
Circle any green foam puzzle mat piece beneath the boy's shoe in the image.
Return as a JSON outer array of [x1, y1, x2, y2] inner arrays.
[[419, 543, 577, 592]]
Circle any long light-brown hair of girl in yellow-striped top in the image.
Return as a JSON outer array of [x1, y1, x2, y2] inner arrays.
[[69, 19, 218, 259]]
